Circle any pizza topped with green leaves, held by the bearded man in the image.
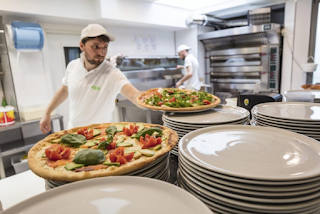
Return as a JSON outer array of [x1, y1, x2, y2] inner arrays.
[[137, 88, 221, 112]]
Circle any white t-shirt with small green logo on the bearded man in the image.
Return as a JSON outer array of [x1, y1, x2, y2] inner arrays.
[[62, 54, 129, 129]]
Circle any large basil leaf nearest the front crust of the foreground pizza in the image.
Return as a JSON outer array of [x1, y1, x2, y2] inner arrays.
[[73, 149, 106, 166]]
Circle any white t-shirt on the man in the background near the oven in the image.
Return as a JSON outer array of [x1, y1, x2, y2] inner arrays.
[[183, 54, 201, 91]]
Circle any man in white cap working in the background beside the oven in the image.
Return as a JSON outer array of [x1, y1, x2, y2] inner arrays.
[[176, 45, 201, 91]]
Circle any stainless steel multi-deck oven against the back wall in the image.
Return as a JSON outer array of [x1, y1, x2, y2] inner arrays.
[[199, 24, 281, 102]]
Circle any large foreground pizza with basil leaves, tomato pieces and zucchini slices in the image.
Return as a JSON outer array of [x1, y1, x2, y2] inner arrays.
[[28, 122, 178, 182]]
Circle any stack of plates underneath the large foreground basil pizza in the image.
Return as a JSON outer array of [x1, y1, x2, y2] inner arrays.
[[45, 153, 170, 190]]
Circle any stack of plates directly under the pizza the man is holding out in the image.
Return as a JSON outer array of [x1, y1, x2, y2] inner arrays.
[[162, 105, 250, 155]]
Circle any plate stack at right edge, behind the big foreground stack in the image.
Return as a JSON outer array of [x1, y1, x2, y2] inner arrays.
[[251, 102, 320, 140]]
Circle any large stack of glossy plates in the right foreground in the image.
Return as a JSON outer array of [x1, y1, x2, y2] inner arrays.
[[178, 126, 320, 214]]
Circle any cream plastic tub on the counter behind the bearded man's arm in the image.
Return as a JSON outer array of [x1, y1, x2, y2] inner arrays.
[[19, 104, 55, 121]]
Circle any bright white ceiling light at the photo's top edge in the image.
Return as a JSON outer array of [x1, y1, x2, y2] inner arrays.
[[154, 0, 230, 10]]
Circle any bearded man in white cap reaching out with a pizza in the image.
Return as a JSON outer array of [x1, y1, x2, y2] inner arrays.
[[40, 24, 139, 133]]
